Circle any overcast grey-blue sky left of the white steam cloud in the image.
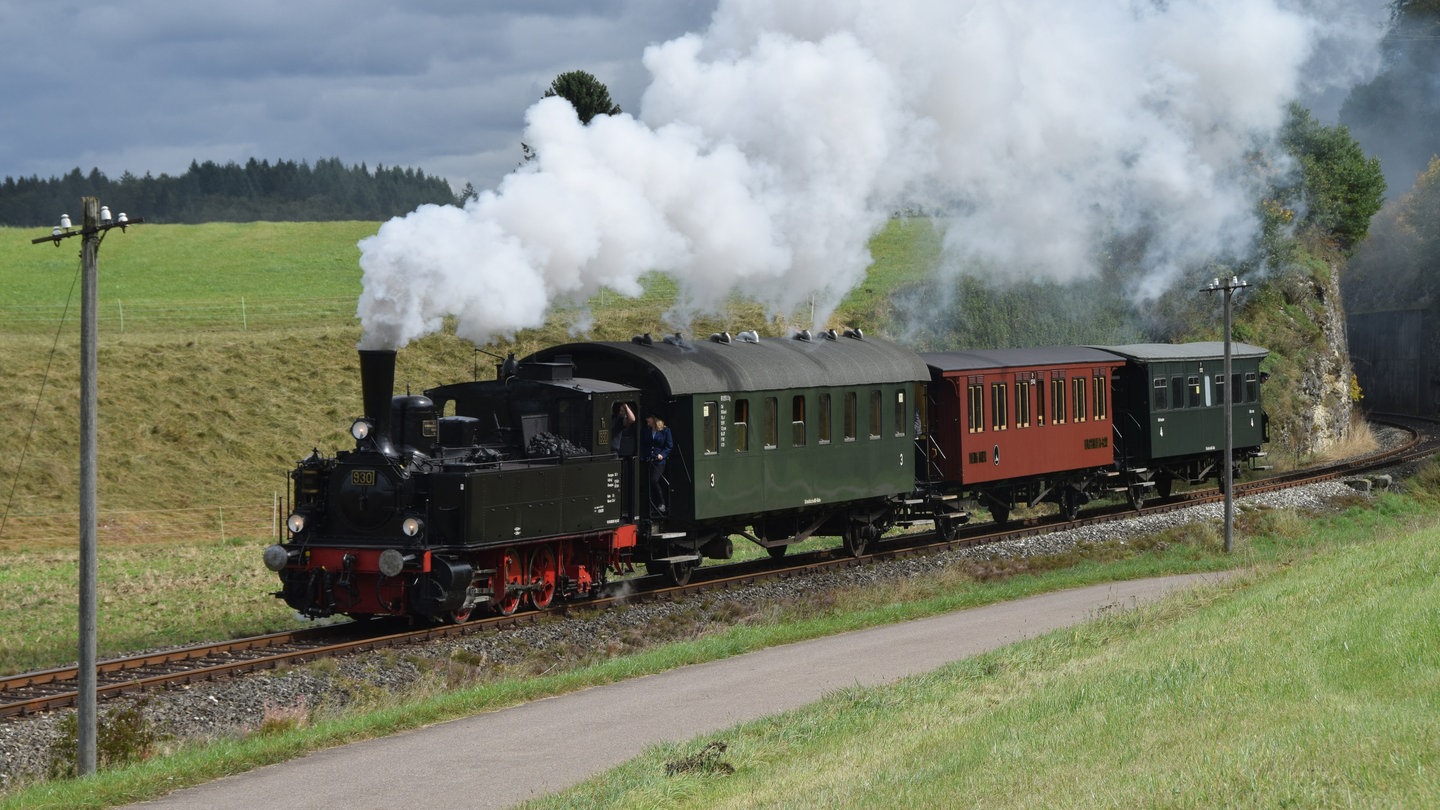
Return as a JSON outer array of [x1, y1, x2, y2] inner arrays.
[[0, 0, 714, 190]]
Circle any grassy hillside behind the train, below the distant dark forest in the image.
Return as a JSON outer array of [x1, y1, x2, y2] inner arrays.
[[0, 222, 936, 672]]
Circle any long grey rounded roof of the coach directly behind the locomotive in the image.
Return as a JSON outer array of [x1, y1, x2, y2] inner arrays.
[[527, 336, 930, 396]]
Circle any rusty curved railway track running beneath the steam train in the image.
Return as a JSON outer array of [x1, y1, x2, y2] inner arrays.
[[0, 415, 1440, 719]]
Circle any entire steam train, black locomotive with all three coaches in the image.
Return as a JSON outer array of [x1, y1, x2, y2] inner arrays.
[[265, 330, 1267, 623]]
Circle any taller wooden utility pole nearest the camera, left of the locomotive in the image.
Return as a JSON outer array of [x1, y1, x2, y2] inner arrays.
[[30, 197, 144, 777]]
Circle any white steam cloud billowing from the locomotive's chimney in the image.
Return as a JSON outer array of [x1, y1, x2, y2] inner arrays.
[[360, 0, 1384, 347]]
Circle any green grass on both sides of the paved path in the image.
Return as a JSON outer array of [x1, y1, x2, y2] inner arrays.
[[0, 481, 1440, 809]]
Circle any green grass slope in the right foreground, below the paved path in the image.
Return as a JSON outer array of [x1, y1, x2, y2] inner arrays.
[[531, 495, 1440, 809]]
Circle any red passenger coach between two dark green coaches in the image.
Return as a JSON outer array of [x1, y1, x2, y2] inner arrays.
[[920, 346, 1125, 523]]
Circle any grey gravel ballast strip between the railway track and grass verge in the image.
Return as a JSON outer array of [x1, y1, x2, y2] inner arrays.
[[0, 472, 1382, 788]]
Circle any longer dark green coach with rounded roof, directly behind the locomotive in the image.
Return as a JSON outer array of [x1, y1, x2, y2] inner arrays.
[[531, 331, 929, 545]]
